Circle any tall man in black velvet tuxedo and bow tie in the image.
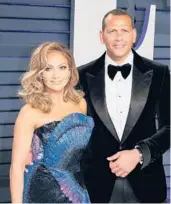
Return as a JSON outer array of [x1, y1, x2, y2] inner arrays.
[[79, 9, 170, 203]]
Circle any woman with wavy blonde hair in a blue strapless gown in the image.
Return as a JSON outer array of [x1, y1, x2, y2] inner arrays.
[[10, 42, 94, 203]]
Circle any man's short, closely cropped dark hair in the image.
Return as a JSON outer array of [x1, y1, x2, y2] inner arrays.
[[102, 9, 134, 30]]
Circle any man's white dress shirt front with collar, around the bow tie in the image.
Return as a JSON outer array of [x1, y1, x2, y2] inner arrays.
[[105, 51, 133, 140]]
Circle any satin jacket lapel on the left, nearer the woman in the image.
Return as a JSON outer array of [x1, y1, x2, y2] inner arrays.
[[86, 55, 120, 142]]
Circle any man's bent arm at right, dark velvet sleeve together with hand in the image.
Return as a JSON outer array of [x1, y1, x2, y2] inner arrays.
[[107, 67, 170, 177]]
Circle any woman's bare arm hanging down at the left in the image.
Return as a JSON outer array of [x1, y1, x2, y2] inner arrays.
[[10, 105, 35, 203]]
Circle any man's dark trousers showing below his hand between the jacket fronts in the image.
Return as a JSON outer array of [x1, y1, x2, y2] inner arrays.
[[110, 178, 140, 203]]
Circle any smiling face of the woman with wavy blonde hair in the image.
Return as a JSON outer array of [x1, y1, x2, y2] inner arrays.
[[42, 51, 71, 92]]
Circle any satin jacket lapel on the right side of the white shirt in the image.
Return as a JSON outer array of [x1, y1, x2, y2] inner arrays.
[[121, 52, 153, 144]]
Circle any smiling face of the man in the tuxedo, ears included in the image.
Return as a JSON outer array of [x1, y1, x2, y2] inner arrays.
[[100, 14, 136, 63]]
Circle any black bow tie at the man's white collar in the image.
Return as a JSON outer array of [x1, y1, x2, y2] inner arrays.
[[108, 64, 131, 80]]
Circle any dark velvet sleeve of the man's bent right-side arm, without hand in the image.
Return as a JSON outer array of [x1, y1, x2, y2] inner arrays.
[[137, 67, 170, 168]]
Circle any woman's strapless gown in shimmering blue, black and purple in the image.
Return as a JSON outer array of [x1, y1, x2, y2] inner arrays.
[[23, 113, 94, 203]]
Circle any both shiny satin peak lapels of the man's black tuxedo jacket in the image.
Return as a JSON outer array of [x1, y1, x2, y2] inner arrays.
[[86, 50, 153, 144]]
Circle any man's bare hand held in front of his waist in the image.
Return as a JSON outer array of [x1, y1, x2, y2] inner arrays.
[[107, 149, 140, 178]]
